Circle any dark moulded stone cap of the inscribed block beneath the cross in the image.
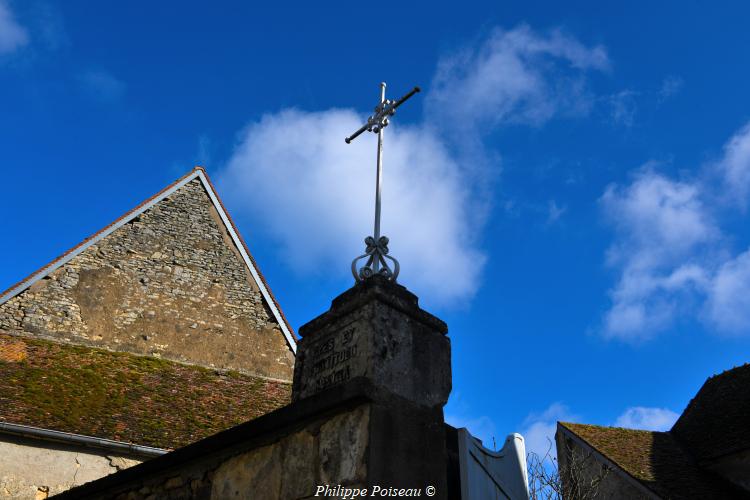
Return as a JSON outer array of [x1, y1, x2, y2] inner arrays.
[[298, 275, 448, 337]]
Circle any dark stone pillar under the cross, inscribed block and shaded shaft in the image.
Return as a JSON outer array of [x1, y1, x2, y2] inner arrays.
[[292, 276, 451, 498]]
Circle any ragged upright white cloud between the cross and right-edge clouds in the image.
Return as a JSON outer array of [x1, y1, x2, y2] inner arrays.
[[600, 167, 720, 340]]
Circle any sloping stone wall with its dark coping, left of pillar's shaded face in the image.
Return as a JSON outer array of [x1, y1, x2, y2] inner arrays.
[[55, 388, 373, 500]]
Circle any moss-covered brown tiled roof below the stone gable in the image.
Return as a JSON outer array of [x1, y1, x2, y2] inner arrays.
[[0, 332, 291, 448]]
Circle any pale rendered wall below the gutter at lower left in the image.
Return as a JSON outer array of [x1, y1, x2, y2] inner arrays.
[[0, 435, 142, 500]]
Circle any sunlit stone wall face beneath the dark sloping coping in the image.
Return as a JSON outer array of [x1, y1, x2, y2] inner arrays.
[[64, 404, 370, 500]]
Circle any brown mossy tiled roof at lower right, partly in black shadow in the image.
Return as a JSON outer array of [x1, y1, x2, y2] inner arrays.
[[559, 422, 748, 499]]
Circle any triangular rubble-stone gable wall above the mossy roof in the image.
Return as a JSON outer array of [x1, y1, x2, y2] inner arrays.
[[0, 179, 294, 380]]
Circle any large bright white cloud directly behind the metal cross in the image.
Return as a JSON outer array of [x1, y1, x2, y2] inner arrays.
[[220, 110, 485, 303]]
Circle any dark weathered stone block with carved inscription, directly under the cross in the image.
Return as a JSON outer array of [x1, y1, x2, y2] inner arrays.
[[292, 276, 451, 407]]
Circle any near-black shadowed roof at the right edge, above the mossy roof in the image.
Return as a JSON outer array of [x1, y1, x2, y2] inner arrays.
[[672, 364, 750, 460]]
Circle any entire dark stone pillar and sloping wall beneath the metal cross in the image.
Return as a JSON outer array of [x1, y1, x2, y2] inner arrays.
[[60, 276, 451, 500]]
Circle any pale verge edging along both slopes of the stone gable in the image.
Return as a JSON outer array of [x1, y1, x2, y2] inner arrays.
[[0, 167, 297, 353]]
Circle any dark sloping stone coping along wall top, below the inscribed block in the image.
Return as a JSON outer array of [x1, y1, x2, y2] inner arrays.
[[54, 377, 420, 500]]
